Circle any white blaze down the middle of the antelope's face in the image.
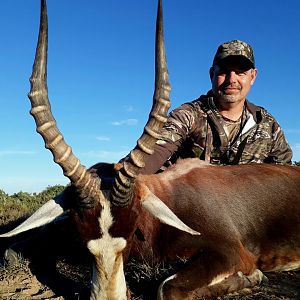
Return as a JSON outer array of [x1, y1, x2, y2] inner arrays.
[[87, 202, 127, 300]]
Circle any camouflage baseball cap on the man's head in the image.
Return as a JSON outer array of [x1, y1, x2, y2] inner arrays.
[[213, 40, 255, 67]]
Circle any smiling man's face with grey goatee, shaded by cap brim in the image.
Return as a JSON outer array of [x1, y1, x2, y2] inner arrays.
[[210, 58, 257, 104]]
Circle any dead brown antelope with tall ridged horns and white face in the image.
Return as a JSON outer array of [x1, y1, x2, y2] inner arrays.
[[2, 0, 300, 300]]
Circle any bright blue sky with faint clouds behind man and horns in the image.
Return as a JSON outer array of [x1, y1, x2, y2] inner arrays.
[[0, 0, 300, 194]]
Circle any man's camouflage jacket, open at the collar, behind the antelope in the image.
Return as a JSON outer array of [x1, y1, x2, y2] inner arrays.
[[142, 92, 292, 174]]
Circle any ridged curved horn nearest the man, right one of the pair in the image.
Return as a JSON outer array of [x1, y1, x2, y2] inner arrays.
[[110, 0, 171, 206]]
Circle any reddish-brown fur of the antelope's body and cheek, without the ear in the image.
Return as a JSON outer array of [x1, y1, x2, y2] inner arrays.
[[95, 159, 300, 299]]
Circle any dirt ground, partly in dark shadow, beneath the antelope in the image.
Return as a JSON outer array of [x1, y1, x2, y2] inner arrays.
[[0, 221, 300, 300]]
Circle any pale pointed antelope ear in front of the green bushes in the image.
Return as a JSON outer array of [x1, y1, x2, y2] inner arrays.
[[0, 189, 67, 238]]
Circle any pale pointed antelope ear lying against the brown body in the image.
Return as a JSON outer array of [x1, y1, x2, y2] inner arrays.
[[140, 185, 201, 235]]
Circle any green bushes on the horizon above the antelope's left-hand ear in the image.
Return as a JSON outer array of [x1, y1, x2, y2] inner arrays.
[[0, 185, 65, 226]]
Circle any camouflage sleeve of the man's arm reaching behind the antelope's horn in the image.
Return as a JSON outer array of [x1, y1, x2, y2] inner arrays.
[[141, 104, 195, 174]]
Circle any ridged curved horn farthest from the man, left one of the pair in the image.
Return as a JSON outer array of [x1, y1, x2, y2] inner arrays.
[[28, 0, 99, 199]]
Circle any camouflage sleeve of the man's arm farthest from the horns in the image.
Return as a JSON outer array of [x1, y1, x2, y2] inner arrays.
[[267, 121, 293, 164]]
